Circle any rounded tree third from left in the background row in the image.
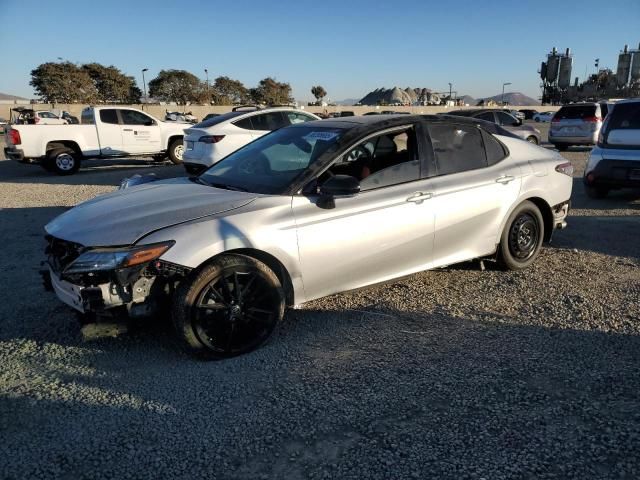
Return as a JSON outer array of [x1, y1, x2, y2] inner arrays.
[[149, 70, 207, 105]]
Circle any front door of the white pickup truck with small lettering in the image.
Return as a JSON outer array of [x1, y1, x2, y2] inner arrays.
[[119, 108, 161, 154]]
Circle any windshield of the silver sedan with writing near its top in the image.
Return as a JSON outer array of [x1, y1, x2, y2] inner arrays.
[[198, 126, 343, 195]]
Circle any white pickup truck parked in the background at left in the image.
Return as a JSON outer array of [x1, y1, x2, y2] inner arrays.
[[4, 106, 191, 175]]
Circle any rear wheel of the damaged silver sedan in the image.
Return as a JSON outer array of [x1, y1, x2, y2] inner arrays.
[[498, 201, 544, 270]]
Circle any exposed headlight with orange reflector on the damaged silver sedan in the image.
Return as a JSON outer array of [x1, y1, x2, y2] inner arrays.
[[63, 241, 175, 274]]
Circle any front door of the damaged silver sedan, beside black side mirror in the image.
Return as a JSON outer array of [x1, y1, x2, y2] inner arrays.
[[292, 127, 434, 299]]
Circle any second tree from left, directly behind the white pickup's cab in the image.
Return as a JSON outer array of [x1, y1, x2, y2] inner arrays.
[[82, 63, 142, 103]]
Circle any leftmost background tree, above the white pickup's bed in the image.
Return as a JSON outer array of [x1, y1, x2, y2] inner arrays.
[[29, 62, 98, 103]]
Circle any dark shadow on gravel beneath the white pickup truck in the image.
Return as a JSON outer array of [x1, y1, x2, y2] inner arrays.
[[0, 159, 186, 186]]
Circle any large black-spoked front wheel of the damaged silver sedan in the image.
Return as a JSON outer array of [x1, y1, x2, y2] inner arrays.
[[173, 255, 285, 359]]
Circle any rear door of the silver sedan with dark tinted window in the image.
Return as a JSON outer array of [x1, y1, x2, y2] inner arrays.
[[429, 123, 522, 267]]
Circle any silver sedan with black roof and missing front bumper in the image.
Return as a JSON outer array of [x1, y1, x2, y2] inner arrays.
[[43, 115, 573, 358]]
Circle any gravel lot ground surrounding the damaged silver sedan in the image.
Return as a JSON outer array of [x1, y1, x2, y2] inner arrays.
[[0, 124, 640, 479]]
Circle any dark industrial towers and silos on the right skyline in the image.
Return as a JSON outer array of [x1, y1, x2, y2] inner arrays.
[[540, 45, 640, 105]]
